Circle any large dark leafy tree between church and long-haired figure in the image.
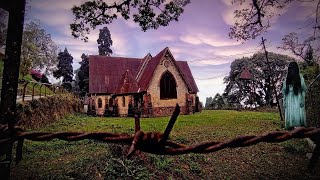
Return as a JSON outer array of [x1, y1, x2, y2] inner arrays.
[[224, 53, 295, 106]]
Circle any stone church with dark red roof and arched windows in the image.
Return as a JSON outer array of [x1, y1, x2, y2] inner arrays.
[[89, 48, 199, 117]]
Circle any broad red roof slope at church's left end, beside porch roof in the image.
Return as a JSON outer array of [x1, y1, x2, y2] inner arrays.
[[89, 55, 142, 94]]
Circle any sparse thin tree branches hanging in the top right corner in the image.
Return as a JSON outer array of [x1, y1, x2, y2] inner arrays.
[[229, 0, 320, 62]]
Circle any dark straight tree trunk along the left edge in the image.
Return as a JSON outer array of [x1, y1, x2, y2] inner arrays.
[[0, 0, 25, 179]]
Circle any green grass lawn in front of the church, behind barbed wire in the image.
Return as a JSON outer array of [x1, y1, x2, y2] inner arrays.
[[12, 110, 318, 179]]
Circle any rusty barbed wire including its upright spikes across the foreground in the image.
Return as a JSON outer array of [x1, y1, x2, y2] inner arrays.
[[0, 105, 320, 172]]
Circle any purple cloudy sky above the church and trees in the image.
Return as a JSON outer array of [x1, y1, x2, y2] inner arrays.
[[27, 0, 315, 102]]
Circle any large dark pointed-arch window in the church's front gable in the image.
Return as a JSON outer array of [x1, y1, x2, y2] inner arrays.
[[160, 71, 177, 99]]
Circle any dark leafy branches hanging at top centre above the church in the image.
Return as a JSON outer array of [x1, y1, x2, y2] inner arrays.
[[70, 0, 190, 41]]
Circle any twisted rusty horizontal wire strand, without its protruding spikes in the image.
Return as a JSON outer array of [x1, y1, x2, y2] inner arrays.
[[0, 127, 320, 155]]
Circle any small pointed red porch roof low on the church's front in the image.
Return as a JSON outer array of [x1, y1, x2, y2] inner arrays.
[[114, 70, 140, 94]]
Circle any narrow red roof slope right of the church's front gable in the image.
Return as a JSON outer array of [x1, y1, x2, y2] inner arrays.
[[176, 61, 199, 93]]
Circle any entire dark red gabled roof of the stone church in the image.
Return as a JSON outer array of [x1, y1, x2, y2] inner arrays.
[[89, 47, 199, 94]]
